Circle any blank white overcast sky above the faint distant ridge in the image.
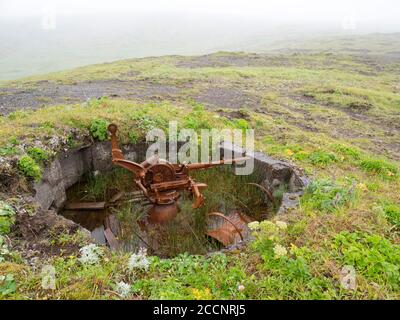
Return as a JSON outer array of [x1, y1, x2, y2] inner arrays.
[[0, 0, 400, 24]]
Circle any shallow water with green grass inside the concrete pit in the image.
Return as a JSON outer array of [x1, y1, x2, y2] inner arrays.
[[61, 166, 273, 257]]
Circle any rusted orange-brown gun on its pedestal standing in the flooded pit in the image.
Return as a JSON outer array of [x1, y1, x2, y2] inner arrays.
[[108, 124, 249, 223]]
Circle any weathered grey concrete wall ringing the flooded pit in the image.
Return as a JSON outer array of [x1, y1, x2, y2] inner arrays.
[[34, 142, 308, 214]]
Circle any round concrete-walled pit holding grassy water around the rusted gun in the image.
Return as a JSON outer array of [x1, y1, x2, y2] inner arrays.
[[36, 143, 307, 257]]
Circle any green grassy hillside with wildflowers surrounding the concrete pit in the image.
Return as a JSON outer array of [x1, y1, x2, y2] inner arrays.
[[0, 38, 400, 299]]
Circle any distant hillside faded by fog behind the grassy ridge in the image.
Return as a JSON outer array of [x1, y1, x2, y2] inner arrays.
[[0, 15, 400, 80]]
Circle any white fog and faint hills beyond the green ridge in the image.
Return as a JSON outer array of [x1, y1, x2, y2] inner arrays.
[[0, 0, 400, 79]]
